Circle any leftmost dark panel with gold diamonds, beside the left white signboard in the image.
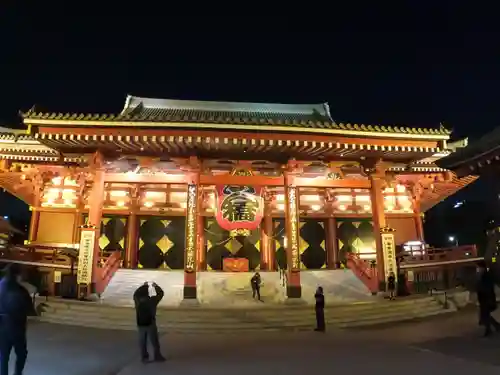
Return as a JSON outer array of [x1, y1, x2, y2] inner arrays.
[[84, 215, 127, 258]]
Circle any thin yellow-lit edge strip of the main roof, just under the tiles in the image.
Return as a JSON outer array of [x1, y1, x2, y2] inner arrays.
[[24, 115, 450, 141]]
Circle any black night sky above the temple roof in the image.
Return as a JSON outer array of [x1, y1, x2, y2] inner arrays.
[[0, 7, 500, 242]]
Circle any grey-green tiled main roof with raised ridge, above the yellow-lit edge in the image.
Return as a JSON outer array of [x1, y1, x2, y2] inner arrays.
[[19, 96, 450, 136]]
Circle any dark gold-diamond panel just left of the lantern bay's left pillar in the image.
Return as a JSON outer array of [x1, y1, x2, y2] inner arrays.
[[138, 216, 186, 269]]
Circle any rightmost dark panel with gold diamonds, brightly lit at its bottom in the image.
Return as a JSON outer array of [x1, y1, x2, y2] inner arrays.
[[337, 218, 375, 260]]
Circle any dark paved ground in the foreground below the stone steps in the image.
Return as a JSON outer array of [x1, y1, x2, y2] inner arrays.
[[8, 311, 500, 375]]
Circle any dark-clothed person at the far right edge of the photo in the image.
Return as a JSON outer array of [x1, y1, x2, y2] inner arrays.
[[476, 262, 500, 336]]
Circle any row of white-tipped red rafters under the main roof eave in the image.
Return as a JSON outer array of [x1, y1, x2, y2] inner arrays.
[[35, 133, 446, 160]]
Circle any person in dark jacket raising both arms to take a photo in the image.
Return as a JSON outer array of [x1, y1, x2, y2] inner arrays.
[[134, 282, 165, 362]]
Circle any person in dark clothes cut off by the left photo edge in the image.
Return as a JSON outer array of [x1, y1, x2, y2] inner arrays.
[[0, 263, 36, 375]]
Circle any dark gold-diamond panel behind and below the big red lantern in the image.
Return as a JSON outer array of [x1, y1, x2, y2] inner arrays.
[[205, 218, 260, 271]]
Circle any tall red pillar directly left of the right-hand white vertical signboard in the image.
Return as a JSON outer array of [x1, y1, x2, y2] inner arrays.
[[370, 176, 387, 291]]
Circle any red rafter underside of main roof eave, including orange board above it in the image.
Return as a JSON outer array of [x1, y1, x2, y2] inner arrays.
[[30, 128, 442, 160]]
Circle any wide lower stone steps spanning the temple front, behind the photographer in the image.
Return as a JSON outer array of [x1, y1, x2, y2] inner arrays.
[[37, 296, 457, 333]]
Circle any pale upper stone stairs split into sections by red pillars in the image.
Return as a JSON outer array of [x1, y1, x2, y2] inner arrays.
[[101, 270, 371, 308]]
